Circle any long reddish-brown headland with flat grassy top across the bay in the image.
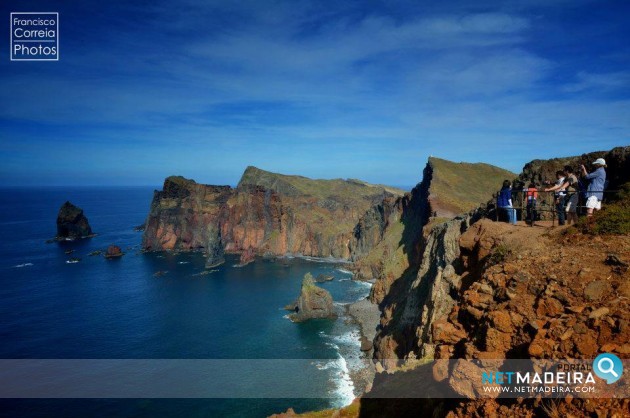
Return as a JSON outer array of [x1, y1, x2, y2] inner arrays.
[[143, 167, 403, 265]]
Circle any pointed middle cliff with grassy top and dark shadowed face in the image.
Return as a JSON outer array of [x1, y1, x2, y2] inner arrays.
[[355, 157, 515, 304]]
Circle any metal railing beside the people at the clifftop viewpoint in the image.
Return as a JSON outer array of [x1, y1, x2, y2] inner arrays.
[[494, 189, 620, 226]]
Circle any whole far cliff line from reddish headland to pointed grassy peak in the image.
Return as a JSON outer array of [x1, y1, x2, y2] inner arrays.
[[143, 158, 506, 272]]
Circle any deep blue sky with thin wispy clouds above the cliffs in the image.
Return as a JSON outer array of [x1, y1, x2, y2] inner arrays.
[[0, 0, 630, 185]]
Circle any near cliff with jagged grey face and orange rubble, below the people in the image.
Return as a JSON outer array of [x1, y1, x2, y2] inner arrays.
[[270, 147, 630, 417]]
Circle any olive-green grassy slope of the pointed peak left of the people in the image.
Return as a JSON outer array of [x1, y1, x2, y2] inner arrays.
[[429, 157, 517, 215]]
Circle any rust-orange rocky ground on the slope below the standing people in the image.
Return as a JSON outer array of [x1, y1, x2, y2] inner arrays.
[[274, 220, 630, 417]]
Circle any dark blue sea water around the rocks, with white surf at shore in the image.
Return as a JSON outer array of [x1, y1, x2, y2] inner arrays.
[[0, 187, 369, 417]]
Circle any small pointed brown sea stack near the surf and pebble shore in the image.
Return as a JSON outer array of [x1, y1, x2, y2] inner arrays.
[[290, 273, 337, 322]]
